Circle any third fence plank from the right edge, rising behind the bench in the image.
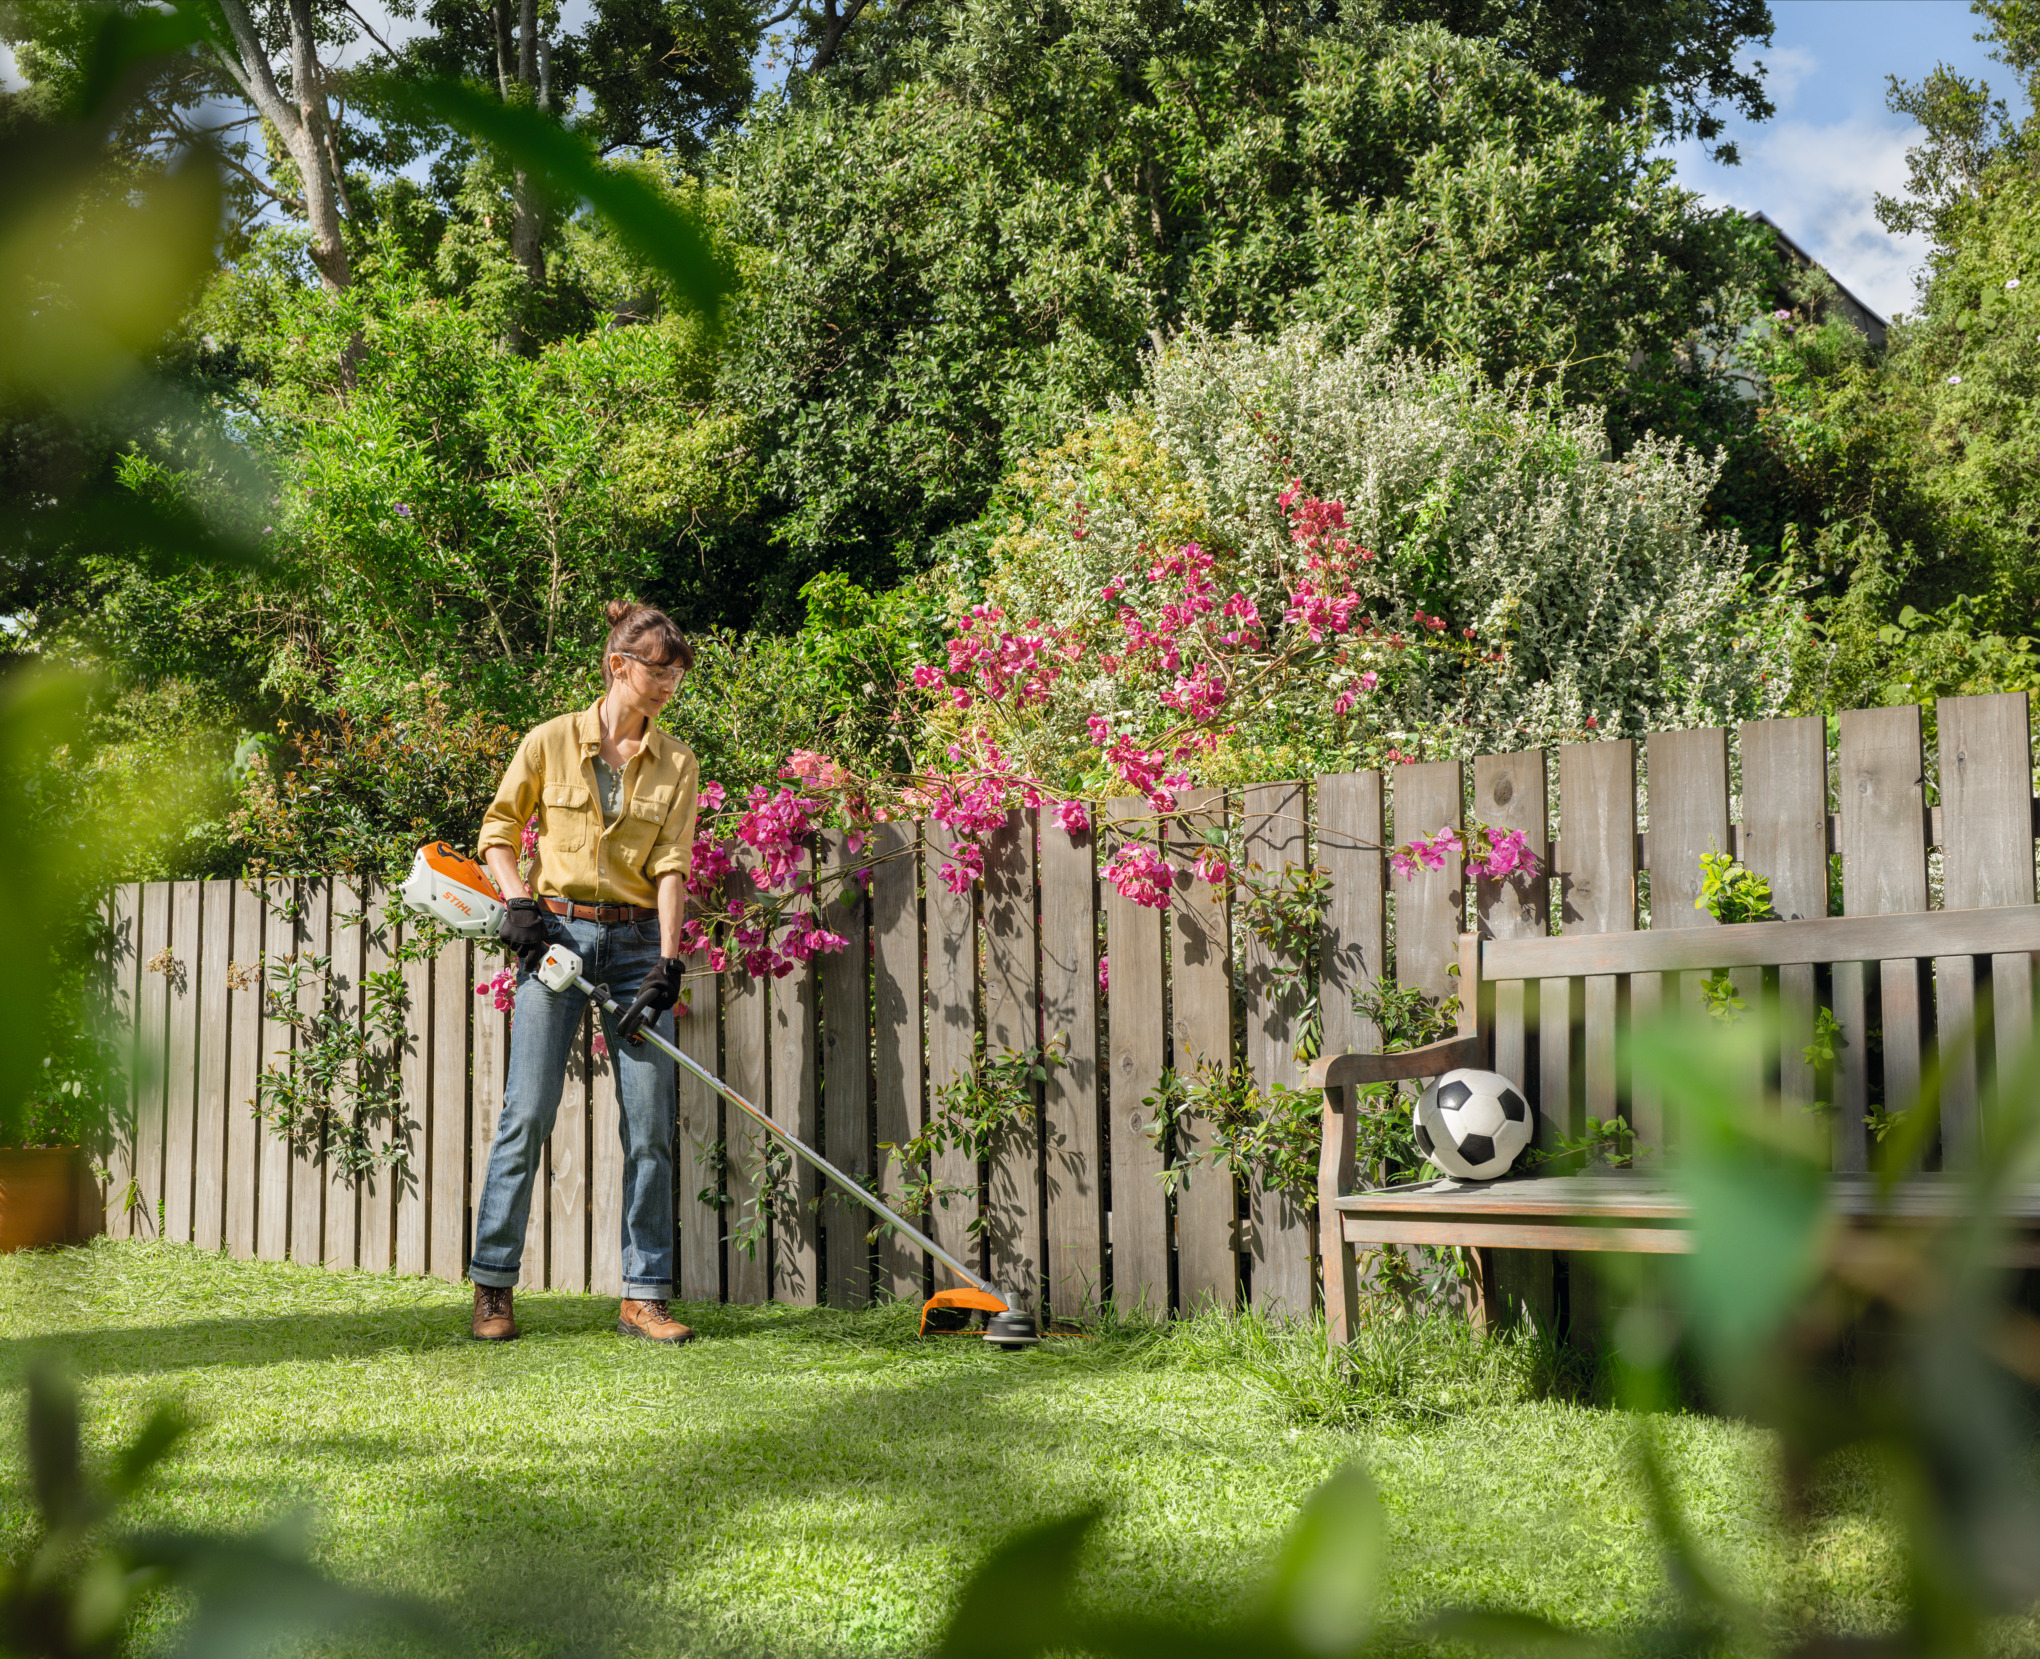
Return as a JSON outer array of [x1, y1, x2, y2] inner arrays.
[[1738, 714, 1828, 1110]]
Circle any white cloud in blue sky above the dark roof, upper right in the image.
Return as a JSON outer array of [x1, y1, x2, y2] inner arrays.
[[1673, 118, 1928, 316]]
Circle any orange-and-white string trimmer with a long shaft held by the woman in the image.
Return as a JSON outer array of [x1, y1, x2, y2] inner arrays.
[[398, 841, 1038, 1351]]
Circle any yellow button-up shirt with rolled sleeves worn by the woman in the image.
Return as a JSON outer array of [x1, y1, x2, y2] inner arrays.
[[479, 702, 702, 906]]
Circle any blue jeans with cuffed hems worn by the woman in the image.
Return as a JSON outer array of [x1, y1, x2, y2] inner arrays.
[[467, 918, 673, 1302]]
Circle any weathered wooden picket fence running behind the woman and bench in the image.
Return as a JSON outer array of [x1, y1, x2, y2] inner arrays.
[[106, 696, 2034, 1314]]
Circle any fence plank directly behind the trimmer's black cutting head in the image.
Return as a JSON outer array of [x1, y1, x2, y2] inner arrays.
[[983, 812, 1042, 1306]]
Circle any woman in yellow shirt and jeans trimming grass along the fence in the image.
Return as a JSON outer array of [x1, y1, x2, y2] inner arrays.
[[469, 600, 700, 1343]]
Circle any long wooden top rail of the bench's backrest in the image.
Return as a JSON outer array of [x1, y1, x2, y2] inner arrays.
[[1481, 904, 2040, 979]]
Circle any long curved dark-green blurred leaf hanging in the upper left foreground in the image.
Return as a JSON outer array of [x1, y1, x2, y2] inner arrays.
[[379, 80, 736, 316]]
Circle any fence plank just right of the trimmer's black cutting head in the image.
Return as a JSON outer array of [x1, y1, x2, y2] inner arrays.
[[1040, 795, 1106, 1318]]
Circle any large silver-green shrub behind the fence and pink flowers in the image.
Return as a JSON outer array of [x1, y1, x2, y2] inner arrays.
[[987, 326, 1791, 769]]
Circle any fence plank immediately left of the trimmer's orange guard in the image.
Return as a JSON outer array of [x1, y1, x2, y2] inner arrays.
[[869, 824, 928, 1300]]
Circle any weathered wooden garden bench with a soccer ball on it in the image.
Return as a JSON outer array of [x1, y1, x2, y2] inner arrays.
[[1310, 904, 2040, 1343]]
